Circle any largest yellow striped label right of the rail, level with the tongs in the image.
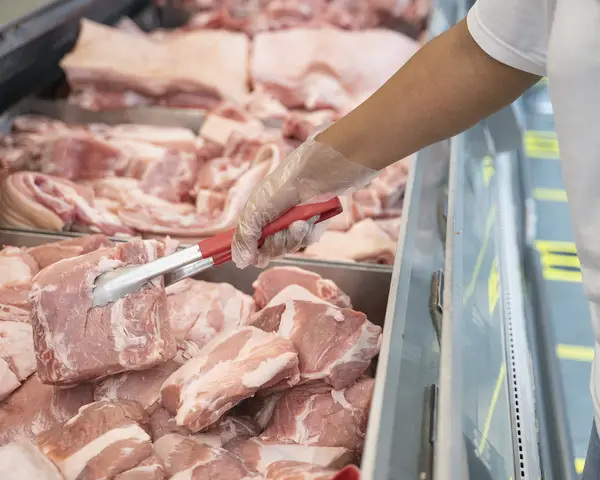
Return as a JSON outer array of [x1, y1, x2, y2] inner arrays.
[[536, 240, 581, 282]]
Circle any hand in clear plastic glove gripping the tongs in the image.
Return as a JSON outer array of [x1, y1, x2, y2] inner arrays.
[[231, 138, 378, 268]]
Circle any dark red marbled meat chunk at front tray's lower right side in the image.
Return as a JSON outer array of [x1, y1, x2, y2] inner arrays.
[[260, 378, 375, 453]]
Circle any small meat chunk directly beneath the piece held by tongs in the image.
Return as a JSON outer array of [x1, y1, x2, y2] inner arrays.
[[94, 361, 181, 413]]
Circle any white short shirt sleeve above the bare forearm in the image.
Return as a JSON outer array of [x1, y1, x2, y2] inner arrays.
[[467, 0, 549, 76]]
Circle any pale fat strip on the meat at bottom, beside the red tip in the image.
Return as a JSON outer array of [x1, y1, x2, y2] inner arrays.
[[251, 442, 348, 473]]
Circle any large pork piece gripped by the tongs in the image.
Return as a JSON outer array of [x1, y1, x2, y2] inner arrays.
[[31, 239, 176, 385]]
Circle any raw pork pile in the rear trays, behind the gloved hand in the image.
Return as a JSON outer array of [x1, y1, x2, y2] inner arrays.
[[0, 10, 417, 264]]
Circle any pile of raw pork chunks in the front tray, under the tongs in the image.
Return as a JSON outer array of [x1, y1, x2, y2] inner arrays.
[[0, 235, 381, 480]]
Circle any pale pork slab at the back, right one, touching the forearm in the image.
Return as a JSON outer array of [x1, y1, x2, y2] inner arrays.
[[251, 28, 417, 113]]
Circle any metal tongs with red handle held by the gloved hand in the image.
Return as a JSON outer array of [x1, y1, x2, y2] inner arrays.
[[93, 197, 343, 307]]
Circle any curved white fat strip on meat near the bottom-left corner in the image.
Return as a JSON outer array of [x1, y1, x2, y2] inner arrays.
[[56, 425, 150, 480]]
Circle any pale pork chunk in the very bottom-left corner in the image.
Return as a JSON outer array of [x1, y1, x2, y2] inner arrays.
[[0, 440, 64, 480]]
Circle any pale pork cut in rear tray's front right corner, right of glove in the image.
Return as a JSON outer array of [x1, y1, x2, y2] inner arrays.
[[303, 218, 396, 264]]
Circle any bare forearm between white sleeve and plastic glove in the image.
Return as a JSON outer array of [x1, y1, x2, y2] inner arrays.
[[317, 21, 539, 169]]
